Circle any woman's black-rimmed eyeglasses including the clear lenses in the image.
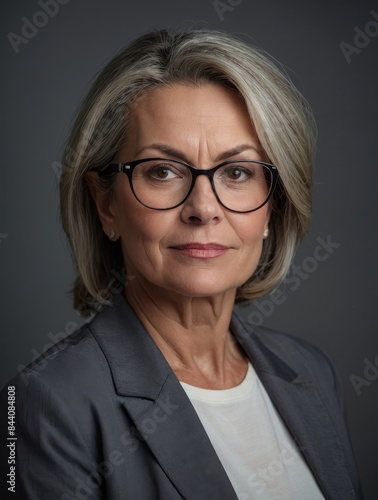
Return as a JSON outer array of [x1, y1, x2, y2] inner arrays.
[[92, 158, 278, 213]]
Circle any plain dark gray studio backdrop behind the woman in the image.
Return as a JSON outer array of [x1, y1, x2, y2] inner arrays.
[[0, 0, 378, 499]]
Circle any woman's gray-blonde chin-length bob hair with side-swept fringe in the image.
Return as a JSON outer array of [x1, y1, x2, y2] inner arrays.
[[60, 29, 315, 316]]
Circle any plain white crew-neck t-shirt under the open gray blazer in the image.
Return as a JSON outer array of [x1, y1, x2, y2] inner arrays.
[[181, 363, 324, 500]]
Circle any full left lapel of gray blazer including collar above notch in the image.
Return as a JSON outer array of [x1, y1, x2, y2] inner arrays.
[[91, 297, 237, 500]]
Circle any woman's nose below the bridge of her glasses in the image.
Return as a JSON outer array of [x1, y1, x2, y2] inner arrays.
[[181, 175, 224, 224]]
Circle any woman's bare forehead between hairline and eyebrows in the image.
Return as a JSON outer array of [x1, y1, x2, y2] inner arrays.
[[126, 83, 258, 157]]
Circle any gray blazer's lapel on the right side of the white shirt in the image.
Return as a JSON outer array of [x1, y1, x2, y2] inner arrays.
[[232, 316, 357, 500]]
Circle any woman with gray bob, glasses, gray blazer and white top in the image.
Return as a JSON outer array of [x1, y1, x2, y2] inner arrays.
[[3, 30, 361, 500]]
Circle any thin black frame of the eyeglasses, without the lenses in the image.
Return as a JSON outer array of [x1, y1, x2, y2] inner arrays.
[[91, 158, 278, 213]]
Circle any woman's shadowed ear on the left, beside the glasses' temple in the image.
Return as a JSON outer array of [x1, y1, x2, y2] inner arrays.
[[85, 172, 119, 241]]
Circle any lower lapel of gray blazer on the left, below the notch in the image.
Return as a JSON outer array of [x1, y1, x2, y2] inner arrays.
[[125, 374, 237, 500]]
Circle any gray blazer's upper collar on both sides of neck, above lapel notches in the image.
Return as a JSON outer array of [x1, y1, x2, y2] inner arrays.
[[91, 295, 306, 400]]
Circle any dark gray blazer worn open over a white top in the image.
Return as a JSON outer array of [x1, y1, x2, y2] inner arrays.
[[0, 296, 362, 500]]
